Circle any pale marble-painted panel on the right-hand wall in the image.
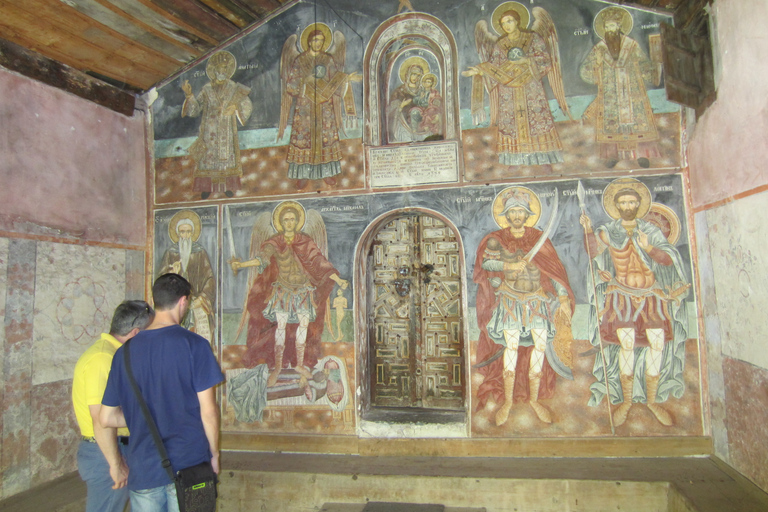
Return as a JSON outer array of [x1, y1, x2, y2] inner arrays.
[[706, 192, 768, 369]]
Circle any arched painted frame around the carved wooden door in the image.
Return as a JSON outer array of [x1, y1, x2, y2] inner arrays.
[[353, 208, 471, 429]]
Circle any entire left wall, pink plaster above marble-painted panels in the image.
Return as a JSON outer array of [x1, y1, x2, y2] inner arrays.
[[0, 70, 147, 497]]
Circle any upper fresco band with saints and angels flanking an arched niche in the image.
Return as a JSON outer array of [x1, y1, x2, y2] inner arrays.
[[152, 0, 682, 205]]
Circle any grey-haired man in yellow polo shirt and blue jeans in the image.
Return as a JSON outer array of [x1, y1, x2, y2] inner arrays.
[[72, 300, 154, 512]]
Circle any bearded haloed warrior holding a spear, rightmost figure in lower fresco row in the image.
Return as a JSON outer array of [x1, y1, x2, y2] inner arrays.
[[580, 178, 691, 426]]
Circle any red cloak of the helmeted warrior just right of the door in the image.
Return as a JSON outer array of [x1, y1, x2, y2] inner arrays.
[[472, 226, 575, 410]]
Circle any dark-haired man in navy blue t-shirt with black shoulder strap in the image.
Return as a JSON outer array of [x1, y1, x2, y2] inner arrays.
[[99, 274, 224, 512]]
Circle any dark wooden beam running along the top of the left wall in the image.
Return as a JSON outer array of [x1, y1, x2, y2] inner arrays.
[[0, 39, 136, 117]]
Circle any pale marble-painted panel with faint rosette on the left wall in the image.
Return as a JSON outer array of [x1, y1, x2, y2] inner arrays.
[[32, 242, 126, 385]]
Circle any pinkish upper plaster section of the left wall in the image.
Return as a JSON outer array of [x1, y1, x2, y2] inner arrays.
[[0, 70, 146, 245]]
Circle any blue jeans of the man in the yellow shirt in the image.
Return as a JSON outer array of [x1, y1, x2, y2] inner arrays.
[[77, 441, 128, 512]]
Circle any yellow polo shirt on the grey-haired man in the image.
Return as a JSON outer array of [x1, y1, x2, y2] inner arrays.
[[72, 333, 128, 437]]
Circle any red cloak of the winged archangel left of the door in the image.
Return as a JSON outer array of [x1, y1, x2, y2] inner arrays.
[[243, 233, 339, 368]]
